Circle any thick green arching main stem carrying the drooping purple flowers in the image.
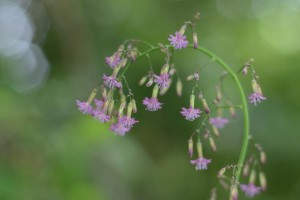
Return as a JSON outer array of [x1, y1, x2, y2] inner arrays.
[[121, 45, 250, 182]]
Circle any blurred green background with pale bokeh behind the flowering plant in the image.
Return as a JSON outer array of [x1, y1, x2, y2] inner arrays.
[[0, 0, 300, 200]]
